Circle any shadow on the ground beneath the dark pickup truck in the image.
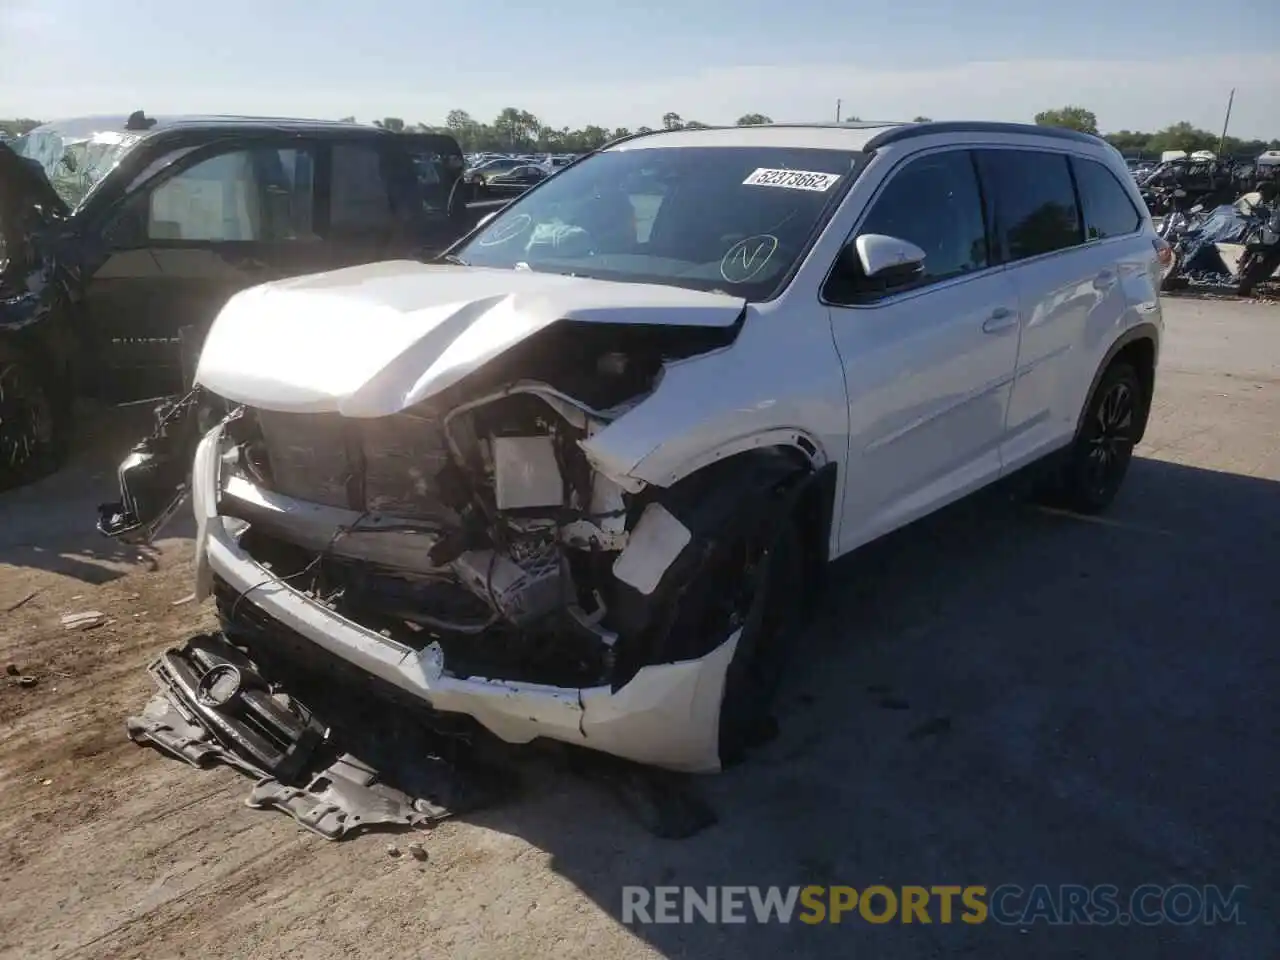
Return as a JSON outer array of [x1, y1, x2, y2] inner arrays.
[[0, 403, 195, 593]]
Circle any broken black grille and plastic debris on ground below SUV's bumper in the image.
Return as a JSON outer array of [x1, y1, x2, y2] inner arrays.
[[127, 634, 716, 844]]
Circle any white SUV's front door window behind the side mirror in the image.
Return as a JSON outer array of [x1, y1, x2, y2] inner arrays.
[[858, 150, 987, 283]]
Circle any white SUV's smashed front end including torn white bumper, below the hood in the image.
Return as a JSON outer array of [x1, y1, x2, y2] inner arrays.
[[107, 308, 757, 771]]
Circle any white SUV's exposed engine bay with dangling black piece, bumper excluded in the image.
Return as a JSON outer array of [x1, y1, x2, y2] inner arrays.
[[99, 316, 752, 727]]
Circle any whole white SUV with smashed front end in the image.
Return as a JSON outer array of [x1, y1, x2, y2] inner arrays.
[[112, 123, 1166, 771]]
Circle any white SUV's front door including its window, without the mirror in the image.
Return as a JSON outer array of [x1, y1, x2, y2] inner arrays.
[[824, 150, 1019, 552]]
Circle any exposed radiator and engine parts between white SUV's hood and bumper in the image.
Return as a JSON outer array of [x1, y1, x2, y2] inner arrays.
[[223, 383, 628, 685]]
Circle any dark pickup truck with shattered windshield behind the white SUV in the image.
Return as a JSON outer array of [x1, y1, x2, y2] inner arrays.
[[0, 111, 506, 489]]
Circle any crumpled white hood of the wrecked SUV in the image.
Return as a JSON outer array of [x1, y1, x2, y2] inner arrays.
[[196, 261, 746, 417]]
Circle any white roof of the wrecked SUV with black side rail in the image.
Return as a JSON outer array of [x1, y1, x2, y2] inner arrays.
[[609, 120, 1105, 151]]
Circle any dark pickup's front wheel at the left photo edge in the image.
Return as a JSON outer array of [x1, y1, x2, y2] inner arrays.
[[0, 343, 69, 490]]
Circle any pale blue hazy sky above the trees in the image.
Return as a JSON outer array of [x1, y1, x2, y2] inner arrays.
[[0, 0, 1280, 140]]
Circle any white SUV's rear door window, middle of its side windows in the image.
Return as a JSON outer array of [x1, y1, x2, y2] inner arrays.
[[978, 150, 1083, 261]]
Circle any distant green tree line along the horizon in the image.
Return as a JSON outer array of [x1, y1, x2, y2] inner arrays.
[[10, 106, 1280, 156]]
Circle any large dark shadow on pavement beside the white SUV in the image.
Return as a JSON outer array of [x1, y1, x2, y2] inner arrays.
[[468, 460, 1280, 960]]
